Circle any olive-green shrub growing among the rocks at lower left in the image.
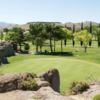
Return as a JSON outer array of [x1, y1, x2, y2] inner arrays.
[[18, 78, 38, 91]]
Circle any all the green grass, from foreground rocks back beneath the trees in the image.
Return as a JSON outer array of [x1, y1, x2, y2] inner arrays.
[[0, 41, 100, 92]]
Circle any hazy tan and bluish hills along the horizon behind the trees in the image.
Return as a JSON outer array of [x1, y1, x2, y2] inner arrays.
[[0, 21, 99, 30]]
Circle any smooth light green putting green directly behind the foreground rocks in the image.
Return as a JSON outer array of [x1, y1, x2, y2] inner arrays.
[[0, 55, 100, 92]]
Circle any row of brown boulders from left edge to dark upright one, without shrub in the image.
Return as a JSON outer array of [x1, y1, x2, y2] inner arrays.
[[0, 69, 60, 93]]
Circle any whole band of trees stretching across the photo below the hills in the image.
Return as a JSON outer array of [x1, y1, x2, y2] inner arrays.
[[0, 23, 100, 53]]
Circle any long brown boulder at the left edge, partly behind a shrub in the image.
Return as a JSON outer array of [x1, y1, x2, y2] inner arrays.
[[0, 73, 34, 92]]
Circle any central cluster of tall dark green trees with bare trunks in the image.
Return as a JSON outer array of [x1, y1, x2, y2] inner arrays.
[[29, 23, 69, 53]]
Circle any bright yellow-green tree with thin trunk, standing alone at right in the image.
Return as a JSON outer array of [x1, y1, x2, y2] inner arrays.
[[74, 30, 92, 53]]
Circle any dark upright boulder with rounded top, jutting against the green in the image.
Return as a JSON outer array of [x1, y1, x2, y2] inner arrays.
[[40, 69, 60, 92]]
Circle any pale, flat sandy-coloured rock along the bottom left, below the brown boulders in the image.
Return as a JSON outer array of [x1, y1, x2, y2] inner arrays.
[[0, 87, 75, 100]]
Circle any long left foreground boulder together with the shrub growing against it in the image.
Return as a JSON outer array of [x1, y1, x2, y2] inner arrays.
[[0, 73, 50, 93]]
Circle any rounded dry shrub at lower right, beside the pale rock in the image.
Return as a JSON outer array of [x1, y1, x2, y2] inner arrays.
[[70, 81, 89, 94]]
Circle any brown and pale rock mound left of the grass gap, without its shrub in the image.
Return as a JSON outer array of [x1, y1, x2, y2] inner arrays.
[[0, 69, 72, 100]]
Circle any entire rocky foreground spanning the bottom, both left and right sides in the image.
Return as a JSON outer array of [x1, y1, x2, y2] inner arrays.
[[0, 69, 100, 100]]
